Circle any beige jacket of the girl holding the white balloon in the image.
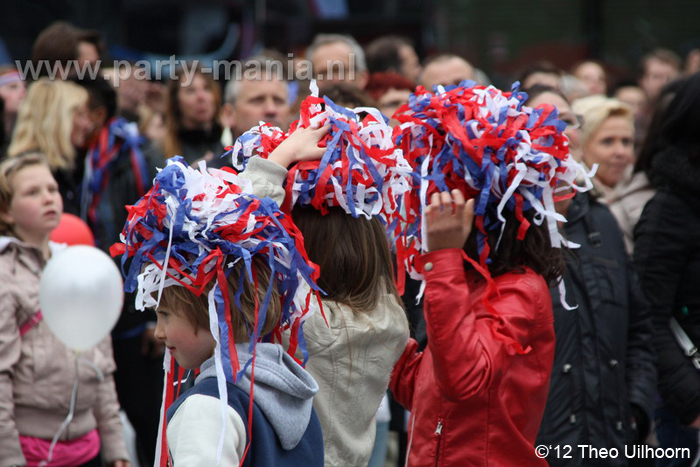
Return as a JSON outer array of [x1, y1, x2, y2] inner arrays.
[[0, 237, 129, 467]]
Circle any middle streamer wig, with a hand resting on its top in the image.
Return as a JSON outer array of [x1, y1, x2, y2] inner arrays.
[[227, 83, 411, 229]]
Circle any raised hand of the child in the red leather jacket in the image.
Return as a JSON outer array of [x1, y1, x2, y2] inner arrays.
[[425, 190, 474, 251]]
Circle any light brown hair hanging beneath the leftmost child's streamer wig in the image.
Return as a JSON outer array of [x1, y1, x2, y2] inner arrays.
[[160, 257, 282, 343]]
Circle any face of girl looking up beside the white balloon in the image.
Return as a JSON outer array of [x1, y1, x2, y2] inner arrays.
[[3, 164, 63, 243]]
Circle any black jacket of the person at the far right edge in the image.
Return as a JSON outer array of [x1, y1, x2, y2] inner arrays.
[[634, 148, 700, 424]]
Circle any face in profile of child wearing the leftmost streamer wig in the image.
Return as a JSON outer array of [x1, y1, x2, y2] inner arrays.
[[156, 305, 216, 370]]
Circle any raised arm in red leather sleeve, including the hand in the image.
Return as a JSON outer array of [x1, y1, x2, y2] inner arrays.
[[419, 191, 552, 400]]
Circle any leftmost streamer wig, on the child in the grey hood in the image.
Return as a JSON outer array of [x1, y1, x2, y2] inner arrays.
[[111, 157, 318, 459]]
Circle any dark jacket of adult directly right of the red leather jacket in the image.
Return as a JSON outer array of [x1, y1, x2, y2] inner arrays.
[[537, 193, 656, 466]]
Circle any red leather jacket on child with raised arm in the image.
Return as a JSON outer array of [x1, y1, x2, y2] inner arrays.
[[390, 249, 554, 467]]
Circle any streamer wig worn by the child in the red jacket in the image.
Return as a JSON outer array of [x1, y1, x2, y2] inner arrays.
[[394, 81, 592, 348]]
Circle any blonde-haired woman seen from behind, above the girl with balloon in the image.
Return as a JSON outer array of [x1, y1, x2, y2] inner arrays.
[[7, 78, 91, 214]]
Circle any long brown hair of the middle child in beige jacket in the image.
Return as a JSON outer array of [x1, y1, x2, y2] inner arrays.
[[292, 206, 402, 312]]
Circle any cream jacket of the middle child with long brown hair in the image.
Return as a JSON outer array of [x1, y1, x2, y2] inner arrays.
[[241, 157, 408, 467]]
